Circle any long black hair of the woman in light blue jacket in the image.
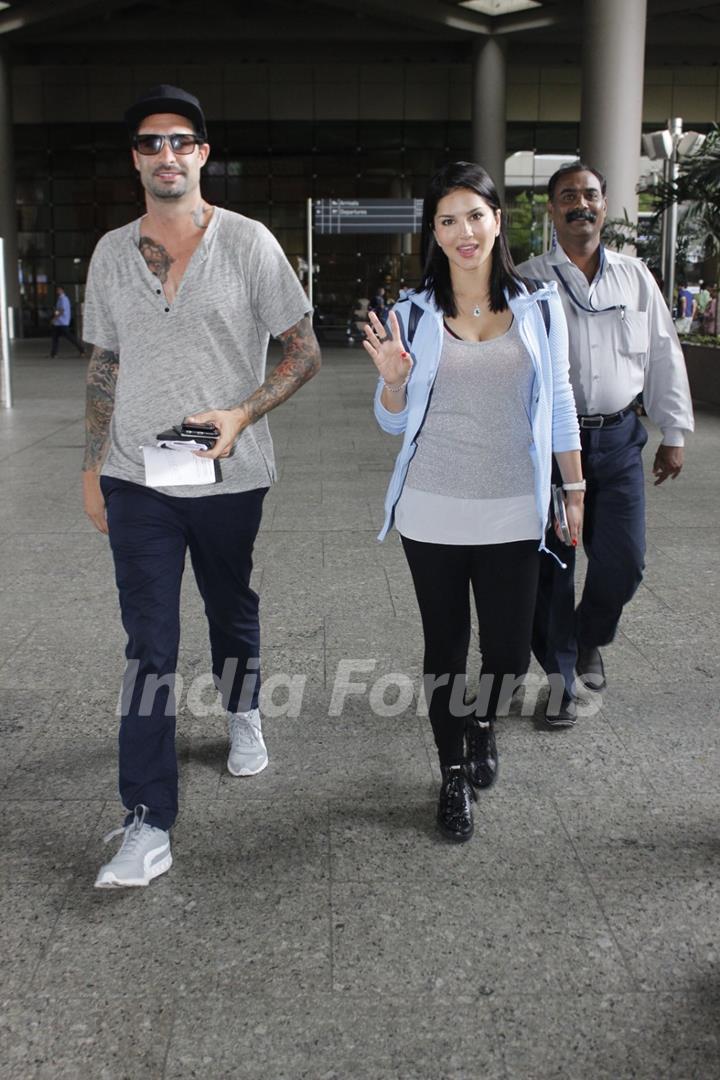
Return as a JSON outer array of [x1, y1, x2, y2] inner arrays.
[[420, 161, 522, 319]]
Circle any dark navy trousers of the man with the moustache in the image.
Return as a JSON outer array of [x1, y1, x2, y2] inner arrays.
[[532, 413, 648, 690]]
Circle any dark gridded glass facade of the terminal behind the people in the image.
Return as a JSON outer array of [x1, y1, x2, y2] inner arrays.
[[15, 121, 578, 335]]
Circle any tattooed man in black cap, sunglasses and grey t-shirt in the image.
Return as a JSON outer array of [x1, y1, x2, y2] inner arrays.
[[83, 85, 320, 888]]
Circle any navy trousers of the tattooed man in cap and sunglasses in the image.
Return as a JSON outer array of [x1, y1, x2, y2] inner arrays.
[[100, 476, 267, 828]]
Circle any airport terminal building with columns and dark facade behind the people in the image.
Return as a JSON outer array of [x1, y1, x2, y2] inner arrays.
[[0, 0, 720, 336]]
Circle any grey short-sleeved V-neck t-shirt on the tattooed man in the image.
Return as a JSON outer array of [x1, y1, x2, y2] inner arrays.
[[83, 206, 310, 497]]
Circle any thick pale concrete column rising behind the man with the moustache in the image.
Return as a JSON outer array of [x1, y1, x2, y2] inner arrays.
[[580, 0, 648, 221]]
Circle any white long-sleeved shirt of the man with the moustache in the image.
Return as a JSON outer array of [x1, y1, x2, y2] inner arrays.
[[518, 245, 694, 446]]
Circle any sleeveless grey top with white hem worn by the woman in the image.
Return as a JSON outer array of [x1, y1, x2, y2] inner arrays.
[[395, 322, 541, 544]]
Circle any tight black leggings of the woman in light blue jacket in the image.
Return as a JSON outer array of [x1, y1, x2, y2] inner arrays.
[[403, 537, 540, 765]]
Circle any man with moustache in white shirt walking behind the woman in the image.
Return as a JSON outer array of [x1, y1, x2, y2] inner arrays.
[[519, 161, 693, 727]]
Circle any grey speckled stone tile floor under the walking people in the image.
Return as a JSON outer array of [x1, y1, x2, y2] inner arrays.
[[0, 342, 720, 1080]]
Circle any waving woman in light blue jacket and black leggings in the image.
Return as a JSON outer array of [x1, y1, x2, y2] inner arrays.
[[364, 162, 584, 840]]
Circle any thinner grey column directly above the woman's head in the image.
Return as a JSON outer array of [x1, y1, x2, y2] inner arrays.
[[473, 38, 507, 202]]
